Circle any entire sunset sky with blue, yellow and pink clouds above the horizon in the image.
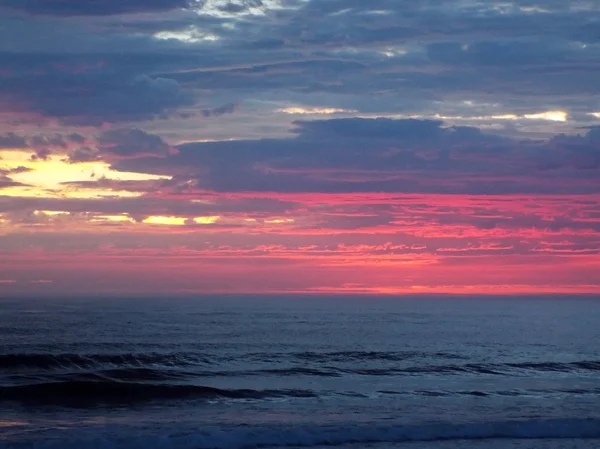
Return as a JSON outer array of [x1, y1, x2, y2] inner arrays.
[[0, 0, 600, 296]]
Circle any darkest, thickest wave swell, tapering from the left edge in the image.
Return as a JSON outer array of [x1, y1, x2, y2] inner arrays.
[[0, 380, 315, 406]]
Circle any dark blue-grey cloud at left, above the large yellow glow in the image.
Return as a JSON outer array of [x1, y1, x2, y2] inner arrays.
[[0, 48, 196, 126]]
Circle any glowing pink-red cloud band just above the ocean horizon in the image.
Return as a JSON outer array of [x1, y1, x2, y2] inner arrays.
[[0, 184, 600, 292]]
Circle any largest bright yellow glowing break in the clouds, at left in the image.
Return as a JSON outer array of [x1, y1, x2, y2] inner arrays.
[[0, 150, 170, 198]]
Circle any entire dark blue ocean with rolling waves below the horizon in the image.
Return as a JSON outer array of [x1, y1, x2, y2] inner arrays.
[[0, 295, 600, 449]]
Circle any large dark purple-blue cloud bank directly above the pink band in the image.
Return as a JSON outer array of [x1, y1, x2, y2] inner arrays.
[[109, 119, 600, 194]]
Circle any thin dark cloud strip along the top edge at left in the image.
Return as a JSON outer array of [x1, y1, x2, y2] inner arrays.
[[0, 0, 193, 16]]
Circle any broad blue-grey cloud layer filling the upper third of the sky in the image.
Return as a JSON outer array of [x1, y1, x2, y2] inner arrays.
[[0, 0, 600, 134]]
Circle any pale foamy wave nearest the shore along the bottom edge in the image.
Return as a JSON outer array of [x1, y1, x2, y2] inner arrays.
[[0, 419, 600, 449]]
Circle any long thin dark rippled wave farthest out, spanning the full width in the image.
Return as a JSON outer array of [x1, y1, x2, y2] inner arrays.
[[0, 351, 600, 377]]
